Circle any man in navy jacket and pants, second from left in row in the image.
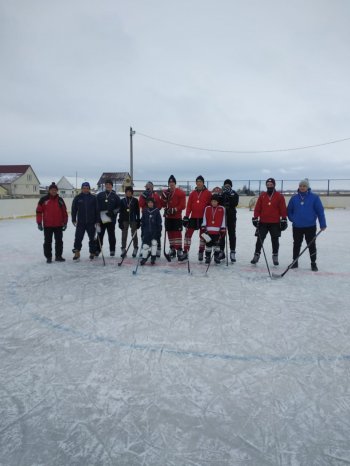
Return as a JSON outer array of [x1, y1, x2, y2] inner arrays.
[[72, 182, 98, 260]]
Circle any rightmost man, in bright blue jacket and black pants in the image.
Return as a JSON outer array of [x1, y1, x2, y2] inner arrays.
[[288, 178, 327, 272]]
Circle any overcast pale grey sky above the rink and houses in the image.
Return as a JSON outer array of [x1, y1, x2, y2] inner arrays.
[[0, 0, 350, 186]]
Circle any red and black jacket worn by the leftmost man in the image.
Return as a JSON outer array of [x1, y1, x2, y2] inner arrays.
[[36, 194, 68, 227]]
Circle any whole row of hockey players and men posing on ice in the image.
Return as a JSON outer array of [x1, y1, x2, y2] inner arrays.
[[36, 175, 327, 271]]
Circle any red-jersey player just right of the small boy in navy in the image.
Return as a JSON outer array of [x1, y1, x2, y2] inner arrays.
[[161, 175, 186, 260]]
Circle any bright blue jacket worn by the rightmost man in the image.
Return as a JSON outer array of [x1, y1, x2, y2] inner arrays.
[[288, 189, 327, 228]]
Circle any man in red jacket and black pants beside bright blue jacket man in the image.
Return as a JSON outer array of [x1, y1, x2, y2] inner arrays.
[[250, 178, 288, 265]]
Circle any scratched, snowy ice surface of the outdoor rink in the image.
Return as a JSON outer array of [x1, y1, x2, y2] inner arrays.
[[0, 209, 350, 466]]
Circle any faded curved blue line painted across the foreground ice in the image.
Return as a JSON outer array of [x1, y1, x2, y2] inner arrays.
[[32, 314, 350, 363]]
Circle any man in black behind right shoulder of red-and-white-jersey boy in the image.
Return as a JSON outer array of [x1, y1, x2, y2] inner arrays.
[[219, 179, 239, 262]]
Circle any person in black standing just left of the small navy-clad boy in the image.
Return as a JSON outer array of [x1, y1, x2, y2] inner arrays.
[[118, 186, 141, 257]]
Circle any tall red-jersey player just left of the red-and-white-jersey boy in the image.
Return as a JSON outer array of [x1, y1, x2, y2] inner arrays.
[[179, 175, 211, 261]]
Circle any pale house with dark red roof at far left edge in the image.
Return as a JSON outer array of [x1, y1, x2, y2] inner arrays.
[[0, 165, 40, 197]]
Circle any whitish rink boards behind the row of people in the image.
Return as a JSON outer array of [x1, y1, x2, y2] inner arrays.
[[0, 196, 350, 220]]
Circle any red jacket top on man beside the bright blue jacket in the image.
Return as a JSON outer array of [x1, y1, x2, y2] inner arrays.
[[254, 191, 287, 223]]
